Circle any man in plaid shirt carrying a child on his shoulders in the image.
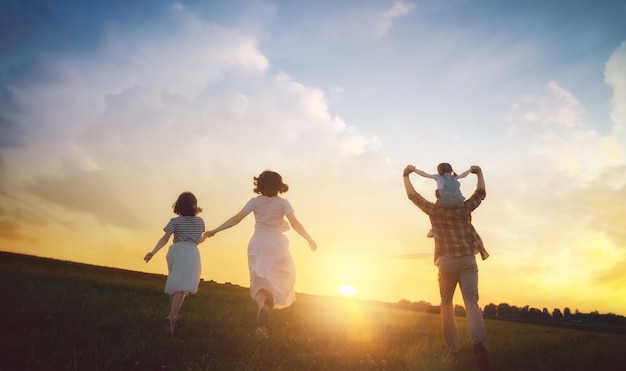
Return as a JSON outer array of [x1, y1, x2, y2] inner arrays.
[[402, 165, 491, 370]]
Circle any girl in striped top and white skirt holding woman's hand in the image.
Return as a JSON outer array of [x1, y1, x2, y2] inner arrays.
[[143, 192, 206, 336]]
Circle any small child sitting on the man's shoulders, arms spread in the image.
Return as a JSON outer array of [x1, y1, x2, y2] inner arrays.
[[415, 162, 470, 237]]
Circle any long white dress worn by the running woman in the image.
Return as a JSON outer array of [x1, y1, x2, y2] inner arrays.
[[243, 196, 296, 309]]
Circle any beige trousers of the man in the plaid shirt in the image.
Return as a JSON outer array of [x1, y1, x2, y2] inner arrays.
[[439, 255, 487, 353]]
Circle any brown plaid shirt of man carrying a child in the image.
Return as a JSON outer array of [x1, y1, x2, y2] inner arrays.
[[409, 189, 489, 265]]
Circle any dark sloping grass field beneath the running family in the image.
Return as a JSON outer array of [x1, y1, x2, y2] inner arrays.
[[0, 252, 626, 371]]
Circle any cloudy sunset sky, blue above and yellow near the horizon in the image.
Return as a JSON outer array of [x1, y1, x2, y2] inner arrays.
[[0, 0, 626, 315]]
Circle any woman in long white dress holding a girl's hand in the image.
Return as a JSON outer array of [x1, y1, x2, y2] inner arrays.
[[204, 170, 317, 339]]
